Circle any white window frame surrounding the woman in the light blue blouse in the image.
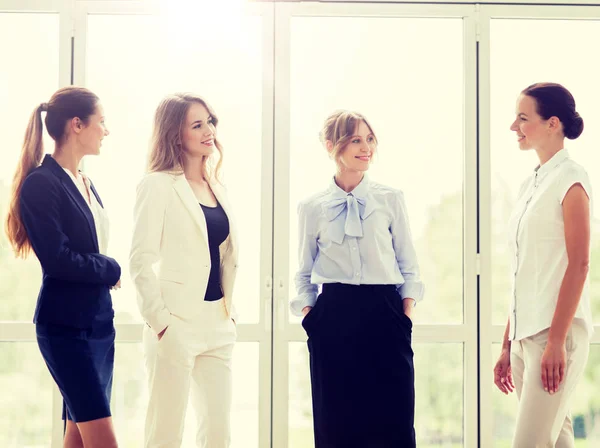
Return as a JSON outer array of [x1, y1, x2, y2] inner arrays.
[[273, 2, 478, 447]]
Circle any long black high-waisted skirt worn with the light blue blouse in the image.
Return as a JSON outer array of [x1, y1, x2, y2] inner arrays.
[[302, 283, 416, 448]]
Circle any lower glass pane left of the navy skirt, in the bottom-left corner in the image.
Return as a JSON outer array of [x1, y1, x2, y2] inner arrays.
[[0, 342, 53, 448]]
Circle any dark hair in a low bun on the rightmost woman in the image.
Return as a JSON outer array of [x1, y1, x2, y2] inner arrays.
[[522, 82, 583, 140]]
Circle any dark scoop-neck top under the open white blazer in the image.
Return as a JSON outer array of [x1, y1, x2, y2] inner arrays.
[[200, 202, 229, 301]]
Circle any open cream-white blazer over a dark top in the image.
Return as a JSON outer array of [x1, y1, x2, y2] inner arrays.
[[129, 172, 238, 333]]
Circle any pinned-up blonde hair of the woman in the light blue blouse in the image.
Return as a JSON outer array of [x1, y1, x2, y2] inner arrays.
[[319, 110, 377, 162]]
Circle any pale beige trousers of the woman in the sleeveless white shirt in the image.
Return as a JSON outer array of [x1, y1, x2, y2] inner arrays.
[[510, 322, 590, 448]]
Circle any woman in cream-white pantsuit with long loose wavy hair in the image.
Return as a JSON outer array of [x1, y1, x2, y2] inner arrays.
[[130, 94, 237, 448]]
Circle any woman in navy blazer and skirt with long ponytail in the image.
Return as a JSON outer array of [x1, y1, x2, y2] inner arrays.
[[6, 87, 121, 448]]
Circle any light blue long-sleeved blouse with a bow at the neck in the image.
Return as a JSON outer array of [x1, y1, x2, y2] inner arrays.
[[291, 176, 424, 316]]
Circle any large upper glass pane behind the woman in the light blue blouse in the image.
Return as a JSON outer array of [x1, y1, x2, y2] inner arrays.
[[289, 17, 464, 324]]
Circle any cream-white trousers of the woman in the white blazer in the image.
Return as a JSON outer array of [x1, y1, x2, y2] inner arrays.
[[143, 299, 236, 448]]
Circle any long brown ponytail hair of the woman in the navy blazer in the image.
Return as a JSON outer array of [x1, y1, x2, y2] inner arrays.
[[5, 86, 98, 258]]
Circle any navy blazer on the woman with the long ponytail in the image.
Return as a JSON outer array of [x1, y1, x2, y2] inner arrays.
[[20, 155, 121, 328]]
